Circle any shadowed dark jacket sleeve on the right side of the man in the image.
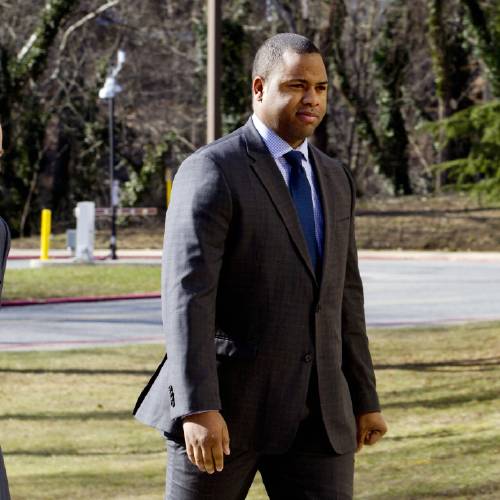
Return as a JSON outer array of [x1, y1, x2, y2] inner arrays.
[[342, 168, 380, 415]]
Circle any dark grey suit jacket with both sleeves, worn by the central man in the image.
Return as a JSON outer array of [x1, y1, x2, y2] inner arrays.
[[134, 120, 379, 453]]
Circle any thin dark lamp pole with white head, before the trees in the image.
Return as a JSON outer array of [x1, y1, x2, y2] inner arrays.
[[99, 50, 125, 260]]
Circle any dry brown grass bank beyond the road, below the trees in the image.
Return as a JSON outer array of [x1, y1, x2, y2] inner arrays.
[[13, 194, 500, 251]]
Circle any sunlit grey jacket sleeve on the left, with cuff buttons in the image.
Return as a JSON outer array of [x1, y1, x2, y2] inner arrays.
[[162, 152, 232, 419]]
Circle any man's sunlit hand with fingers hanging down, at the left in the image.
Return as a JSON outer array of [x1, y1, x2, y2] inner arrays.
[[182, 411, 230, 474]]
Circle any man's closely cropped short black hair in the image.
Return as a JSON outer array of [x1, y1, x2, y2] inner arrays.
[[252, 33, 320, 79]]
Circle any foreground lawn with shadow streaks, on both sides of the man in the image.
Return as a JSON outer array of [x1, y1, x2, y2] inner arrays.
[[0, 323, 500, 500]]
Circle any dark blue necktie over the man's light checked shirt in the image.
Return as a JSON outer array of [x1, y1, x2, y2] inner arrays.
[[283, 150, 320, 273]]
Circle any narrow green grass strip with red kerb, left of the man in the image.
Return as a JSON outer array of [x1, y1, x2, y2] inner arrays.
[[2, 265, 160, 300]]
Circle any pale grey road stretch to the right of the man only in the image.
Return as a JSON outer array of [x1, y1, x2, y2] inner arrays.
[[360, 260, 500, 327]]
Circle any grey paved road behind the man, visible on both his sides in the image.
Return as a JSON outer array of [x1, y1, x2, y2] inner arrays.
[[0, 259, 500, 350]]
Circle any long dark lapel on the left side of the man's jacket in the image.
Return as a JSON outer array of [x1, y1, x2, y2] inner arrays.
[[244, 118, 316, 282]]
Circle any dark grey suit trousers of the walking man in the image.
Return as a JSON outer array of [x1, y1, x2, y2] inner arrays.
[[165, 370, 354, 500]]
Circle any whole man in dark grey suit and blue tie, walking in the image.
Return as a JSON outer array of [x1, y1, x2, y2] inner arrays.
[[134, 34, 386, 500]]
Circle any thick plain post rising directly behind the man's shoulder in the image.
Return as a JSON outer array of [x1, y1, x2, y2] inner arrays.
[[207, 0, 222, 143]]
